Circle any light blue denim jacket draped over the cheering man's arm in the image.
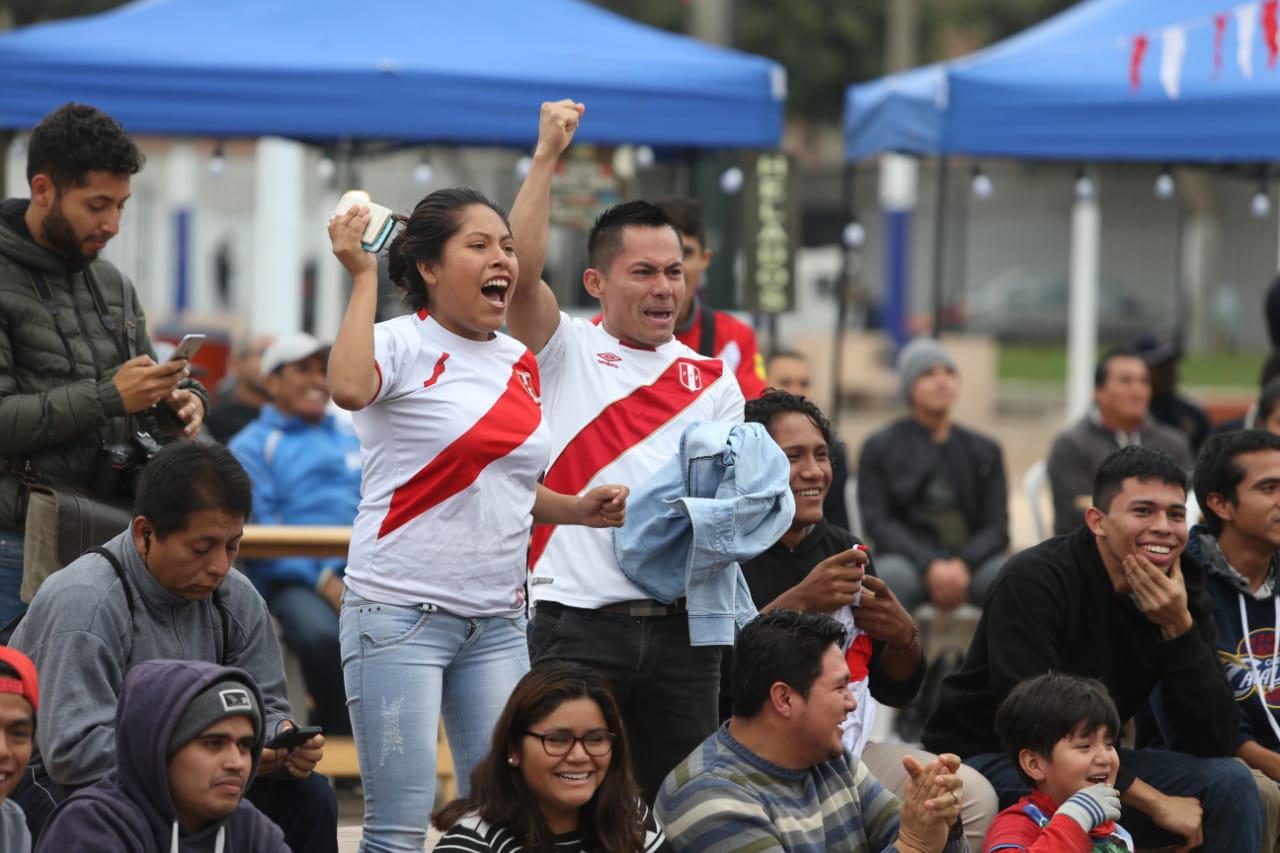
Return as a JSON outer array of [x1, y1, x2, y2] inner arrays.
[[613, 423, 796, 646]]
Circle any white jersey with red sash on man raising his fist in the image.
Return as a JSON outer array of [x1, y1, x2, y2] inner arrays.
[[529, 314, 744, 607]]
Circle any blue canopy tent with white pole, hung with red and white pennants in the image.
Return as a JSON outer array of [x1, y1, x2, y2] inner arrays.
[[844, 0, 1280, 415]]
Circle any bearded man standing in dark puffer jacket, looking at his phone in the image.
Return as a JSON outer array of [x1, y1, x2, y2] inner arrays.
[[0, 104, 207, 625]]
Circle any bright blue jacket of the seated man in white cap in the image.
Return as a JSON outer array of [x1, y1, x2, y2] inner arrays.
[[228, 405, 360, 596]]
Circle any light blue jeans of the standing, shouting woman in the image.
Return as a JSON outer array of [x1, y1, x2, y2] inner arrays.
[[338, 589, 529, 853]]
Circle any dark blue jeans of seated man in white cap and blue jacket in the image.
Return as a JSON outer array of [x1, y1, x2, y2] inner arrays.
[[266, 584, 351, 735]]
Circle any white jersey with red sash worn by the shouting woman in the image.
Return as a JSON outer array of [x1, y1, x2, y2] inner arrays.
[[347, 311, 550, 616]]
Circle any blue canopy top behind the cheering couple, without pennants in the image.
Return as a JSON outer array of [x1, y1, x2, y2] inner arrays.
[[0, 0, 786, 149]]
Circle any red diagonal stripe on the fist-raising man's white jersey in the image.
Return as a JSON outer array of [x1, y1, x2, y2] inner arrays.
[[529, 359, 724, 571]]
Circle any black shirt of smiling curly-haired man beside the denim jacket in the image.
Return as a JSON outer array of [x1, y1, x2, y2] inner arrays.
[[721, 520, 924, 720]]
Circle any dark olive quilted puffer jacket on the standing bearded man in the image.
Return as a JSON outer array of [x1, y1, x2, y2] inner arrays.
[[0, 199, 209, 530]]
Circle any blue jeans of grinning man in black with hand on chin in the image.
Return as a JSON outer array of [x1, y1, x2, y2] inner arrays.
[[964, 749, 1270, 853]]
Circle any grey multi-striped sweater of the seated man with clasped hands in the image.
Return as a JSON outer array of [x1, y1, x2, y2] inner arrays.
[[657, 722, 969, 853]]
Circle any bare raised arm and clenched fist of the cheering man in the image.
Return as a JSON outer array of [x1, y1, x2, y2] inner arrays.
[[507, 100, 586, 353]]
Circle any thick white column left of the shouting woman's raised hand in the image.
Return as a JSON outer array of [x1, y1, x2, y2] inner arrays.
[[248, 137, 306, 334]]
